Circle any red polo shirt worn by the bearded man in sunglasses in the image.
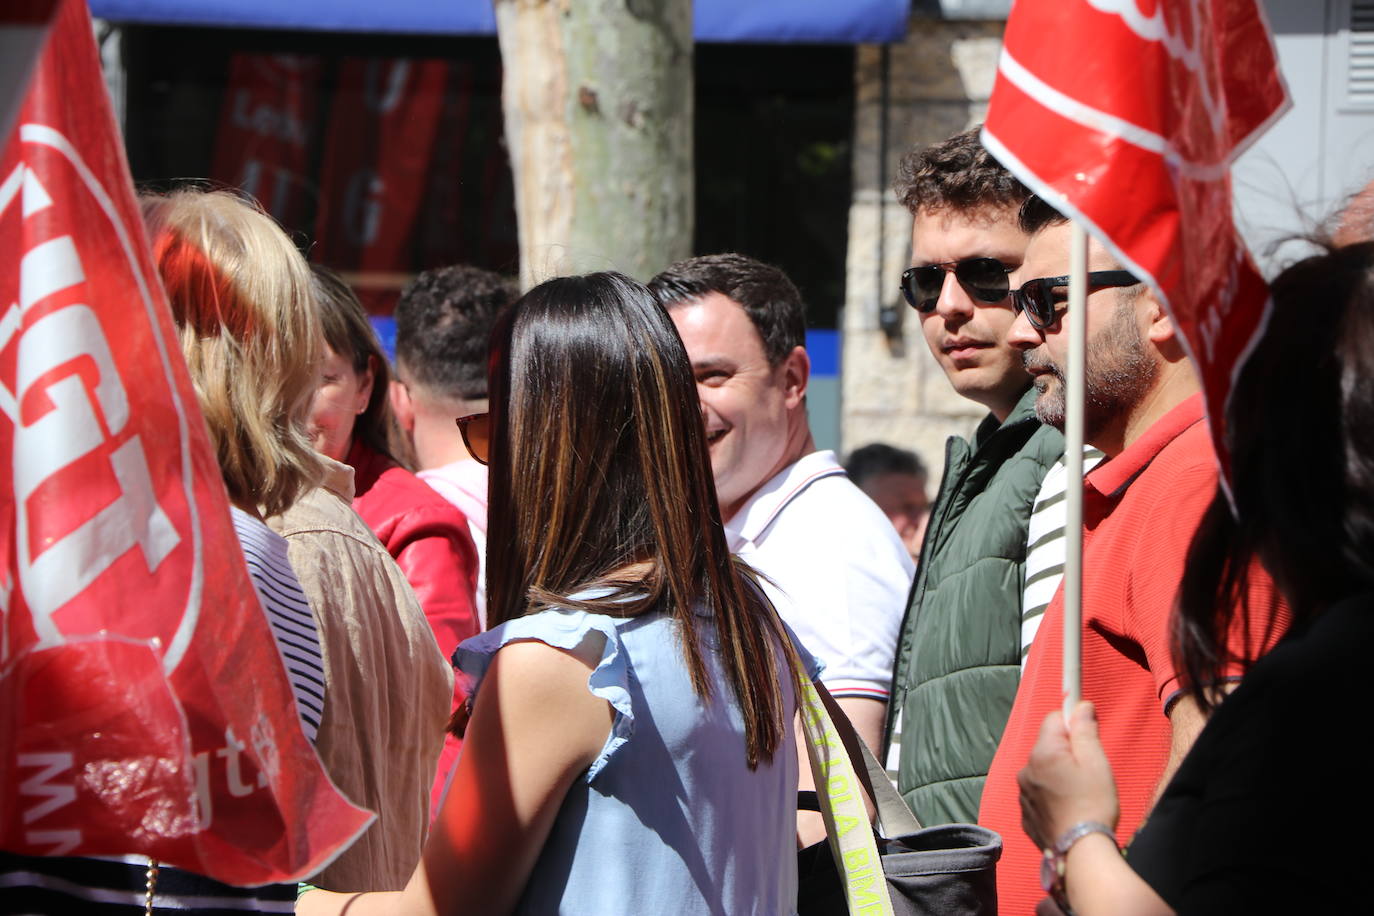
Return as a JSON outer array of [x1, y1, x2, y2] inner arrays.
[[978, 396, 1286, 916]]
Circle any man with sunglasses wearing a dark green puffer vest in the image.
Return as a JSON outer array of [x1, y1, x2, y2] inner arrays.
[[886, 129, 1063, 824]]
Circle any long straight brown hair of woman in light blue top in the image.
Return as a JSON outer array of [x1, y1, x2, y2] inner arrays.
[[486, 273, 796, 768]]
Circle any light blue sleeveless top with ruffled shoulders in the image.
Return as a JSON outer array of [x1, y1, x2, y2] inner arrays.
[[453, 601, 820, 916]]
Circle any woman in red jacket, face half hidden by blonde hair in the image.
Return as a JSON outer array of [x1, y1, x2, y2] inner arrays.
[[308, 264, 480, 814]]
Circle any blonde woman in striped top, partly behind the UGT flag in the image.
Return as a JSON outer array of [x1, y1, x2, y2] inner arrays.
[[0, 192, 326, 916]]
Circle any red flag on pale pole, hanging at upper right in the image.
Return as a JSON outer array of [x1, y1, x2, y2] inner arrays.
[[984, 0, 1287, 483]]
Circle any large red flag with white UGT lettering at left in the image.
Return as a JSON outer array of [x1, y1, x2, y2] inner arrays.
[[0, 0, 370, 884]]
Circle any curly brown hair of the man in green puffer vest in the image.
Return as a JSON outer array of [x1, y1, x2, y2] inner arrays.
[[892, 128, 1031, 214]]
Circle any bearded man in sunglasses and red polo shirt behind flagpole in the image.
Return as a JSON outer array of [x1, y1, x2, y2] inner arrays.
[[978, 198, 1272, 916]]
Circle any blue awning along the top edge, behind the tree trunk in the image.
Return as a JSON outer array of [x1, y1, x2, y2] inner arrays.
[[89, 0, 911, 44]]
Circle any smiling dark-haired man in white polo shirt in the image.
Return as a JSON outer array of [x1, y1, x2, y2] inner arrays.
[[650, 254, 912, 796]]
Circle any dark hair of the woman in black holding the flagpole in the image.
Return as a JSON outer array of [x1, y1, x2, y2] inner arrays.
[[1175, 242, 1374, 709]]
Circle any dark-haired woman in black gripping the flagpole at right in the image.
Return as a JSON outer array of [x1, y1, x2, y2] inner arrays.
[[1021, 243, 1374, 916]]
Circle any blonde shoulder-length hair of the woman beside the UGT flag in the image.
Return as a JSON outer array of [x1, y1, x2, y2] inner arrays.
[[142, 190, 324, 515]]
